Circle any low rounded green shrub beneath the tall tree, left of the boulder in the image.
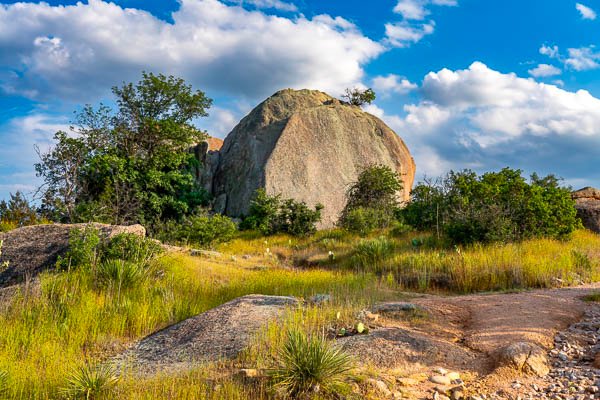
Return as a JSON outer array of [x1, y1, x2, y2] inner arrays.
[[157, 213, 238, 246]]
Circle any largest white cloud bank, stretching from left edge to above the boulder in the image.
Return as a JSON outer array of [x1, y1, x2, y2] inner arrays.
[[0, 0, 384, 101]]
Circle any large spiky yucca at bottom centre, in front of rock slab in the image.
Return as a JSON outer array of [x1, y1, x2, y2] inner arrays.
[[272, 330, 354, 399]]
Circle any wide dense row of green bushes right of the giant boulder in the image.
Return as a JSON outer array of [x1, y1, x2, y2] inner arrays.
[[402, 168, 580, 244]]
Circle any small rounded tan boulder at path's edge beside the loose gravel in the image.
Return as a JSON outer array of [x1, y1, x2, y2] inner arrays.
[[498, 342, 550, 377]]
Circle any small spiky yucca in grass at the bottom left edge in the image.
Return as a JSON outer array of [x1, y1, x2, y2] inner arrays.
[[62, 363, 119, 400]]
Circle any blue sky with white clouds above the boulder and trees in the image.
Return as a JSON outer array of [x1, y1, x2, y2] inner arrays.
[[0, 0, 600, 198]]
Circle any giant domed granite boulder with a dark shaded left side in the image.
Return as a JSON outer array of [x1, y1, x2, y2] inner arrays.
[[212, 89, 415, 227]]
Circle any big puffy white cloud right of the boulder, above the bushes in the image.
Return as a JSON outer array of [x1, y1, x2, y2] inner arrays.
[[370, 62, 600, 182]]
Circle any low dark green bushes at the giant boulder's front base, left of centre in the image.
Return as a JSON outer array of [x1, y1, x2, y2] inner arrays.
[[241, 189, 323, 236]]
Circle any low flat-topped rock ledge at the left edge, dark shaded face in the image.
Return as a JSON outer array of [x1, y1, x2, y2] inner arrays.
[[0, 224, 146, 287]]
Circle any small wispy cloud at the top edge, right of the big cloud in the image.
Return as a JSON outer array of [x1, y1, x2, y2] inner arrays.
[[385, 0, 458, 47]]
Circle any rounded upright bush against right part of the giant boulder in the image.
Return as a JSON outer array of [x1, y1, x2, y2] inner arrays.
[[339, 165, 402, 235]]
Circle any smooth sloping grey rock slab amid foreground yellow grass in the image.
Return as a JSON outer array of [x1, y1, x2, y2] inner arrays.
[[114, 295, 298, 373]]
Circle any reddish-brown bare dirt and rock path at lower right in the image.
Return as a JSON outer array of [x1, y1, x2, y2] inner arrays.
[[342, 284, 600, 399]]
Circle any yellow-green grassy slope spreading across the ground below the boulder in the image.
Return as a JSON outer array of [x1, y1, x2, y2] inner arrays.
[[0, 231, 600, 399]]
